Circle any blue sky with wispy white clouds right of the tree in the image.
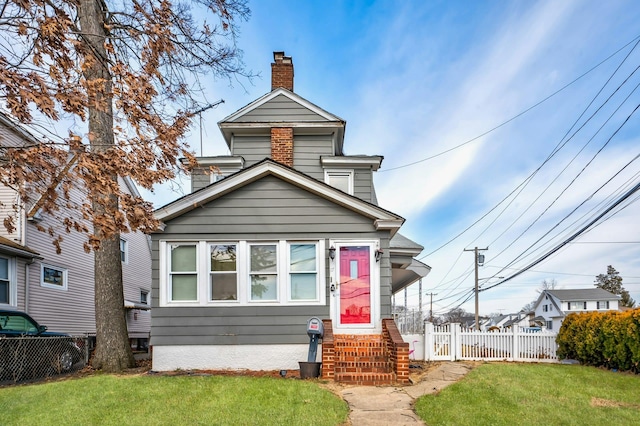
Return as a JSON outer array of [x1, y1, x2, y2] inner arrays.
[[151, 0, 640, 314]]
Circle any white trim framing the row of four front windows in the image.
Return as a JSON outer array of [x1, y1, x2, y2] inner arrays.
[[158, 239, 327, 307]]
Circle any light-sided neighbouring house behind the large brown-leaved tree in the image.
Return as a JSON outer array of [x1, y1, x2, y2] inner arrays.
[[0, 114, 151, 343]]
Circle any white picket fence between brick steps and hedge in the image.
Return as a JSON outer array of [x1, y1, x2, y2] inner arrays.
[[420, 322, 558, 362]]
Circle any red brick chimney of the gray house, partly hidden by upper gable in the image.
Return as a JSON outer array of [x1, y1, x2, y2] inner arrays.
[[271, 52, 293, 167]]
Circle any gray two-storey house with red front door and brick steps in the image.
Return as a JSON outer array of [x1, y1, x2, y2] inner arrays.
[[151, 52, 430, 383]]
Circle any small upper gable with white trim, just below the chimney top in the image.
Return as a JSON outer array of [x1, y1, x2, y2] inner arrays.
[[218, 88, 347, 154]]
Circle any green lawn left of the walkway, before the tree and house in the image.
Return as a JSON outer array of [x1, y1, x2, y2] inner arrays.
[[0, 375, 349, 426]]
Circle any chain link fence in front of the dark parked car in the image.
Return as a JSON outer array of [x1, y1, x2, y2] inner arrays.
[[0, 336, 91, 385]]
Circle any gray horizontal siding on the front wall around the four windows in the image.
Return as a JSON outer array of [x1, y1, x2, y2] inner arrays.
[[152, 176, 391, 345]]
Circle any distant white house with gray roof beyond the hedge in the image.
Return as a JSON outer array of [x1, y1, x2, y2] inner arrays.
[[534, 288, 620, 332]]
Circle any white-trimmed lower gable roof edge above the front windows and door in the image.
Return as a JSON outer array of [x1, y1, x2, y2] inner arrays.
[[154, 158, 404, 236]]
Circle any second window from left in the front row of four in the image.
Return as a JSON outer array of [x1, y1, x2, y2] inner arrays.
[[209, 244, 238, 300]]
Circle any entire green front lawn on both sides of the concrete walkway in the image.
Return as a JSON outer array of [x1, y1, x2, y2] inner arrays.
[[0, 363, 640, 426]]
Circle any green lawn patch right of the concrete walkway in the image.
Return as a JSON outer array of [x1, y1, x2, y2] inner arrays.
[[416, 363, 640, 426]]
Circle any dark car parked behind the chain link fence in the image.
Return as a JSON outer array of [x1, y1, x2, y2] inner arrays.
[[0, 310, 83, 381]]
